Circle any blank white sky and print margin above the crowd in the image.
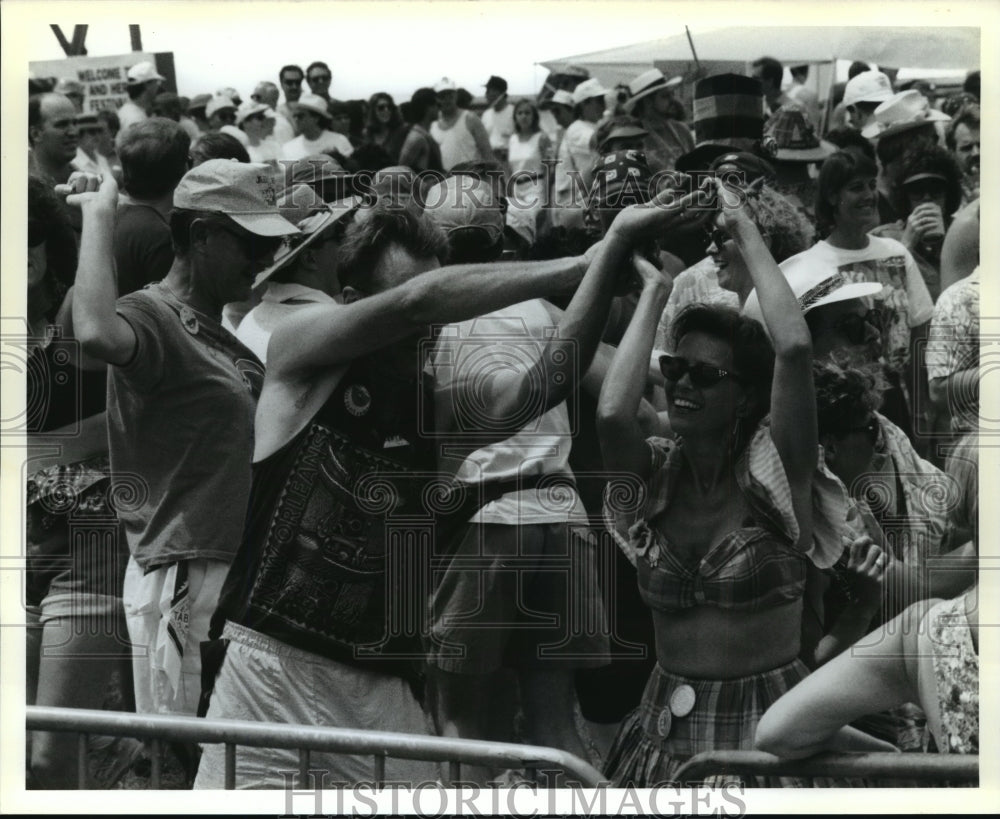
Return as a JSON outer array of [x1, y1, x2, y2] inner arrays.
[[22, 2, 710, 99]]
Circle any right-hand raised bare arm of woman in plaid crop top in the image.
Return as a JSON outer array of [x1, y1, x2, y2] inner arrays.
[[716, 180, 819, 543]]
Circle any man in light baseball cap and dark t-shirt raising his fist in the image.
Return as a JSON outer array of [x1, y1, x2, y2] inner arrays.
[[63, 160, 298, 732]]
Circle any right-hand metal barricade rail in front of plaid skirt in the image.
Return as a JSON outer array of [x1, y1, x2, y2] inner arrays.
[[674, 751, 979, 784]]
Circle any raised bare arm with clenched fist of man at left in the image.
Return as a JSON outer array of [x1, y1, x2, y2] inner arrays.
[[56, 173, 136, 364]]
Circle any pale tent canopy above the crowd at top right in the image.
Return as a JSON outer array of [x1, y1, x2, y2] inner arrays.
[[542, 26, 980, 90]]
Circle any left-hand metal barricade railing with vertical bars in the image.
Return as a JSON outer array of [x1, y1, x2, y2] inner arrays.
[[26, 706, 607, 790]]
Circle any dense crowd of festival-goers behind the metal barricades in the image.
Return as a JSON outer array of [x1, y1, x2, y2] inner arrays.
[[25, 48, 980, 788]]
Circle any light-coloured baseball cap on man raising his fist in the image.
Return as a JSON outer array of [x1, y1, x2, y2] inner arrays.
[[174, 159, 298, 236]]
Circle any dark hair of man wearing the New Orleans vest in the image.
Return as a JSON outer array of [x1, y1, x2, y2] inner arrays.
[[337, 199, 448, 293]]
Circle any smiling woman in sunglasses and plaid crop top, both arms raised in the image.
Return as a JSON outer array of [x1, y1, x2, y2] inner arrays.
[[598, 181, 860, 787]]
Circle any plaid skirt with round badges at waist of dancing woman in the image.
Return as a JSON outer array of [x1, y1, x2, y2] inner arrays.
[[605, 659, 836, 788]]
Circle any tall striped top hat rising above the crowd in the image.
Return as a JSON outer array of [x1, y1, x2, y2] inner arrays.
[[676, 74, 764, 171]]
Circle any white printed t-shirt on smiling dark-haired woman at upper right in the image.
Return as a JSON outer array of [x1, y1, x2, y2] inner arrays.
[[779, 236, 934, 373]]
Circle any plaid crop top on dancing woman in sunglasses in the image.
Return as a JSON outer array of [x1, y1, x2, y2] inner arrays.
[[605, 425, 847, 612]]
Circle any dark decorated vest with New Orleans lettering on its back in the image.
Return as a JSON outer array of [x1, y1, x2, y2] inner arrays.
[[211, 360, 500, 677]]
